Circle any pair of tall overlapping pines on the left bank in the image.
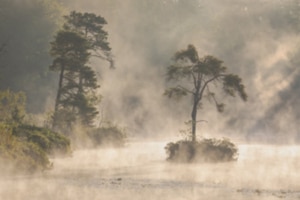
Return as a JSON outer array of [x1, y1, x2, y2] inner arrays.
[[50, 11, 113, 131]]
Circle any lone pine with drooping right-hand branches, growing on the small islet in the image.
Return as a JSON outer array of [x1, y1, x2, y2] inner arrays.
[[164, 45, 247, 142]]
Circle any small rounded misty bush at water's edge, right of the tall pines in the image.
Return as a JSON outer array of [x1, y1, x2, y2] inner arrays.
[[88, 124, 126, 147]]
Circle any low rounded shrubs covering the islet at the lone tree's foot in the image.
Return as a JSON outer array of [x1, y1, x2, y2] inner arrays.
[[165, 139, 238, 162]]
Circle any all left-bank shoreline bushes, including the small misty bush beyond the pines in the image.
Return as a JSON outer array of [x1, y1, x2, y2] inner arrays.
[[0, 90, 126, 174]]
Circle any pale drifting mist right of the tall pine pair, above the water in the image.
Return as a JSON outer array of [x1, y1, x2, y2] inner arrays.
[[64, 0, 300, 141]]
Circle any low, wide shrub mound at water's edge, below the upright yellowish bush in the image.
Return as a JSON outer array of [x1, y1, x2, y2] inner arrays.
[[0, 123, 70, 173]]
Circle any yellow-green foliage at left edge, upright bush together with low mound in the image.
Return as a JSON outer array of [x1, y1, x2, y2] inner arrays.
[[0, 90, 71, 172]]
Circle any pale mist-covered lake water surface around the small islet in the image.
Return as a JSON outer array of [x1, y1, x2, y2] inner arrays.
[[0, 142, 300, 200]]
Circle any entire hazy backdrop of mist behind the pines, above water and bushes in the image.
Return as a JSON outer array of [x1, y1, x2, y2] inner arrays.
[[0, 0, 300, 143]]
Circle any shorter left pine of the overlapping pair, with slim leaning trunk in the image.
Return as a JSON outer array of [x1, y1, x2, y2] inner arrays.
[[50, 31, 89, 128]]
